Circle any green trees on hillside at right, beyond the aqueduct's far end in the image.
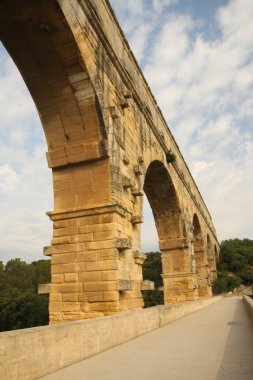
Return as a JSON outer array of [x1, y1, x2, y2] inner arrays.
[[213, 239, 253, 294]]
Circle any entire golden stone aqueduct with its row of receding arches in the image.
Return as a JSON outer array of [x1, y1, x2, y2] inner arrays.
[[0, 0, 219, 323]]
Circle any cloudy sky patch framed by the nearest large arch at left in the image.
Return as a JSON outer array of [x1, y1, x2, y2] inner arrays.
[[0, 43, 52, 261]]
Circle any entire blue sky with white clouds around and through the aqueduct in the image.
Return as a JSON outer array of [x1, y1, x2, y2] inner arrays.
[[0, 0, 253, 261]]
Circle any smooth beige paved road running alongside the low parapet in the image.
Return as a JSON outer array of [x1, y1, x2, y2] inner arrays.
[[42, 298, 253, 380]]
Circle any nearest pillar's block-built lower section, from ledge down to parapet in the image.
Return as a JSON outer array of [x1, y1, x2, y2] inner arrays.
[[46, 204, 143, 323]]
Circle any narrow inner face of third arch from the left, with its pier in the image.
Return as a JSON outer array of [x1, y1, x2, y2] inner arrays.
[[193, 214, 212, 297]]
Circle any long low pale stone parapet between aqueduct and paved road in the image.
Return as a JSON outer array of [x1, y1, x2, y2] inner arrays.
[[0, 296, 222, 380]]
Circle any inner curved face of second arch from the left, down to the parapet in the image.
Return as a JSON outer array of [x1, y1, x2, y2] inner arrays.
[[144, 160, 196, 304]]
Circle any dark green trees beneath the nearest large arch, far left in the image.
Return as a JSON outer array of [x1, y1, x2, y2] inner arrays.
[[0, 259, 51, 331]]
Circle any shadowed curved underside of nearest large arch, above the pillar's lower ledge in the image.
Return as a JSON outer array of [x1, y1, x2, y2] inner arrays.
[[0, 0, 110, 211]]
